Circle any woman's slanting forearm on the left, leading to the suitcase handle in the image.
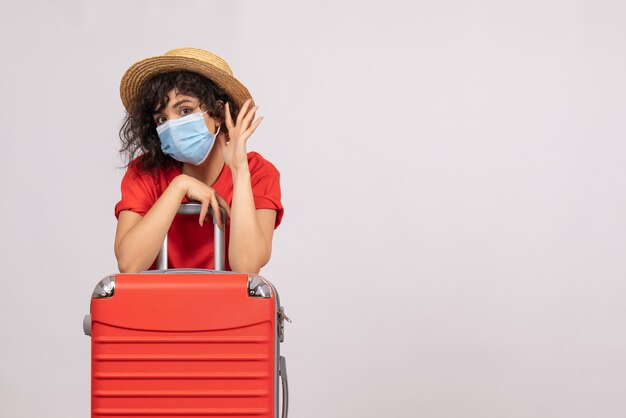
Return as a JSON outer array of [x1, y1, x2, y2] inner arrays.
[[117, 179, 184, 273]]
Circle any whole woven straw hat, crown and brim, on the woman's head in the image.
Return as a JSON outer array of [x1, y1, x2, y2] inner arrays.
[[120, 48, 254, 111]]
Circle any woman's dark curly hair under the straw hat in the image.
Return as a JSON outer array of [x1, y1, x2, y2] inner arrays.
[[119, 71, 239, 174]]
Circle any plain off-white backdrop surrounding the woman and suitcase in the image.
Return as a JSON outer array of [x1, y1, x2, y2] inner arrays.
[[0, 0, 626, 418]]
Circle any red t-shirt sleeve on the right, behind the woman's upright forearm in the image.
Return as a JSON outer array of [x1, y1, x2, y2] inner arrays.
[[248, 152, 285, 229]]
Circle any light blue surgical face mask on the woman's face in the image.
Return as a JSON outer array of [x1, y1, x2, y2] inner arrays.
[[157, 110, 220, 165]]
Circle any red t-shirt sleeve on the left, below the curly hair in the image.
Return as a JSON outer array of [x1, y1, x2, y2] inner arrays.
[[115, 162, 159, 218]]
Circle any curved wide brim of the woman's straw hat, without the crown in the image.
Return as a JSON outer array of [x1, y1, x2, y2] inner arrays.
[[120, 56, 254, 112]]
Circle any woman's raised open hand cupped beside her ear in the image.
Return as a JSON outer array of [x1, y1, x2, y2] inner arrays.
[[217, 99, 263, 171]]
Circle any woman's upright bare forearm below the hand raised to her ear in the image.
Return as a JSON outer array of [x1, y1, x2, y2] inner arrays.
[[228, 167, 269, 273]]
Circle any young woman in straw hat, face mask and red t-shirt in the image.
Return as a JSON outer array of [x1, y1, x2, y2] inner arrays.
[[115, 48, 283, 273]]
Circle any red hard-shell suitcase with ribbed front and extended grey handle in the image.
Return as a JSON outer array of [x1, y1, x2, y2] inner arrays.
[[83, 203, 288, 418]]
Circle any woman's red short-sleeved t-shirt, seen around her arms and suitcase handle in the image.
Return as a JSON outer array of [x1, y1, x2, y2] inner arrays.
[[115, 151, 284, 270]]
